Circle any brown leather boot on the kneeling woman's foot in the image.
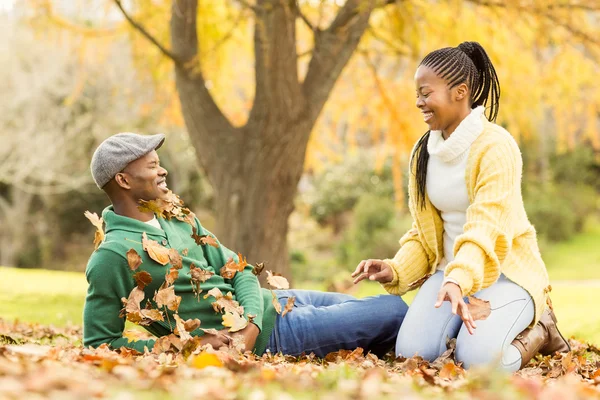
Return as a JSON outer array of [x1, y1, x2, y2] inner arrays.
[[512, 308, 571, 368]]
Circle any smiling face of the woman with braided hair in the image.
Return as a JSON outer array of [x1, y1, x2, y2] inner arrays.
[[415, 65, 471, 137]]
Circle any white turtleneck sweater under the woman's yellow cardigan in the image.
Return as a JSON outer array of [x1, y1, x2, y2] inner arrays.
[[426, 106, 485, 271]]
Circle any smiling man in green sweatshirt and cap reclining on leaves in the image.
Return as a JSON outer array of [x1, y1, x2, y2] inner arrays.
[[83, 133, 408, 357]]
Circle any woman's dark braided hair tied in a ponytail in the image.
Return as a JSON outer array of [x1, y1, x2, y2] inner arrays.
[[411, 42, 500, 208]]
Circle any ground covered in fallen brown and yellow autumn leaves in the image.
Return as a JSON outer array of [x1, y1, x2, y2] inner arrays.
[[0, 319, 600, 400]]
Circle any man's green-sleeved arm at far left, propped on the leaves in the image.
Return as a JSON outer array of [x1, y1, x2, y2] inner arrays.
[[83, 249, 155, 352]]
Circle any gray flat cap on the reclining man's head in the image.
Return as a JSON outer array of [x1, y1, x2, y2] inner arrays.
[[90, 132, 165, 189]]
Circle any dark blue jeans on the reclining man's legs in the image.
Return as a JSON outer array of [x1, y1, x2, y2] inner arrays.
[[267, 290, 408, 357]]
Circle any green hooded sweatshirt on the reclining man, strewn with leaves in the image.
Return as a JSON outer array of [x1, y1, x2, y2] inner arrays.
[[83, 206, 276, 354]]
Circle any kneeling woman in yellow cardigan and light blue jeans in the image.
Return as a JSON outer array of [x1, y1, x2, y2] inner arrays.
[[352, 42, 569, 372]]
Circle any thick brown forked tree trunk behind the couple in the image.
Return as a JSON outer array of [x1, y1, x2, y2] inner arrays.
[[171, 0, 375, 278]]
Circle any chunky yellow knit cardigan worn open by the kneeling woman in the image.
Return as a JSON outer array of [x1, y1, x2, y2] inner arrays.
[[383, 116, 550, 325]]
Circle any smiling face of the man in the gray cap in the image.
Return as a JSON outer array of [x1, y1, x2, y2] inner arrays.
[[121, 150, 169, 201]]
